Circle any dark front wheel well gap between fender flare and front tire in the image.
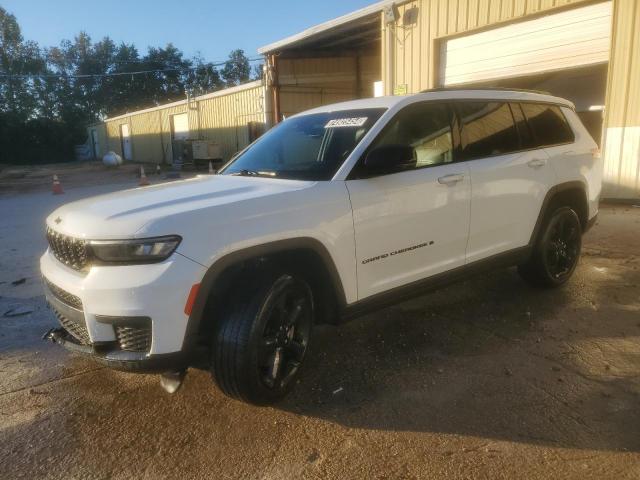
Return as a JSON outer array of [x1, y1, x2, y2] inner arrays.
[[198, 247, 341, 342]]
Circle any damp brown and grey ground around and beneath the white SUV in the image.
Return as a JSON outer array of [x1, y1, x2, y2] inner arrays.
[[0, 171, 640, 480]]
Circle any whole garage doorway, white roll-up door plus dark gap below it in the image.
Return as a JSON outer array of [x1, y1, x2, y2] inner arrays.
[[439, 1, 613, 146]]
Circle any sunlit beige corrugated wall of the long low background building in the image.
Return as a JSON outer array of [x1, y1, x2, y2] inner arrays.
[[100, 82, 265, 163]]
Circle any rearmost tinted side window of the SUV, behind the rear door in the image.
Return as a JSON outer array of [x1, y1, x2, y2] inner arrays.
[[521, 103, 575, 147]]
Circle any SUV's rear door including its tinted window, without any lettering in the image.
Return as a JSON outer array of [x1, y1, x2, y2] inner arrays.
[[457, 101, 555, 263]]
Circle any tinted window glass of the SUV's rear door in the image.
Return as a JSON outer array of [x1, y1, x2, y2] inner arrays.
[[456, 102, 520, 160]]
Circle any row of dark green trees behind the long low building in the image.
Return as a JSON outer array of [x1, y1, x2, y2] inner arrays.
[[0, 7, 262, 163]]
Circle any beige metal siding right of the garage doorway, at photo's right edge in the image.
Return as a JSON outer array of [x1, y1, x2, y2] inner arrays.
[[603, 0, 640, 198]]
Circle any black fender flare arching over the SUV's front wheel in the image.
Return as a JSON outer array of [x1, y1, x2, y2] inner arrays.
[[182, 237, 347, 350]]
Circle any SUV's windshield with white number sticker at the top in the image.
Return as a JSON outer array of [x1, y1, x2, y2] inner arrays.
[[220, 108, 385, 180]]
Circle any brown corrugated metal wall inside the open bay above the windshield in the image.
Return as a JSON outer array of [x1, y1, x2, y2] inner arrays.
[[278, 54, 381, 117]]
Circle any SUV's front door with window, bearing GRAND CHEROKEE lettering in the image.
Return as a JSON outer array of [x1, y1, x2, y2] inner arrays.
[[347, 102, 470, 299]]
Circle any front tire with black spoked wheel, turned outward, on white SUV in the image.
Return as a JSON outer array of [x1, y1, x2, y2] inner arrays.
[[211, 272, 314, 405]]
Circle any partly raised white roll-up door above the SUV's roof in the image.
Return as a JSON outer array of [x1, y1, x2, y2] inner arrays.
[[440, 1, 612, 86]]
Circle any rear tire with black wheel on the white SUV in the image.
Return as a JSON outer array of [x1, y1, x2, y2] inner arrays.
[[518, 207, 582, 288]]
